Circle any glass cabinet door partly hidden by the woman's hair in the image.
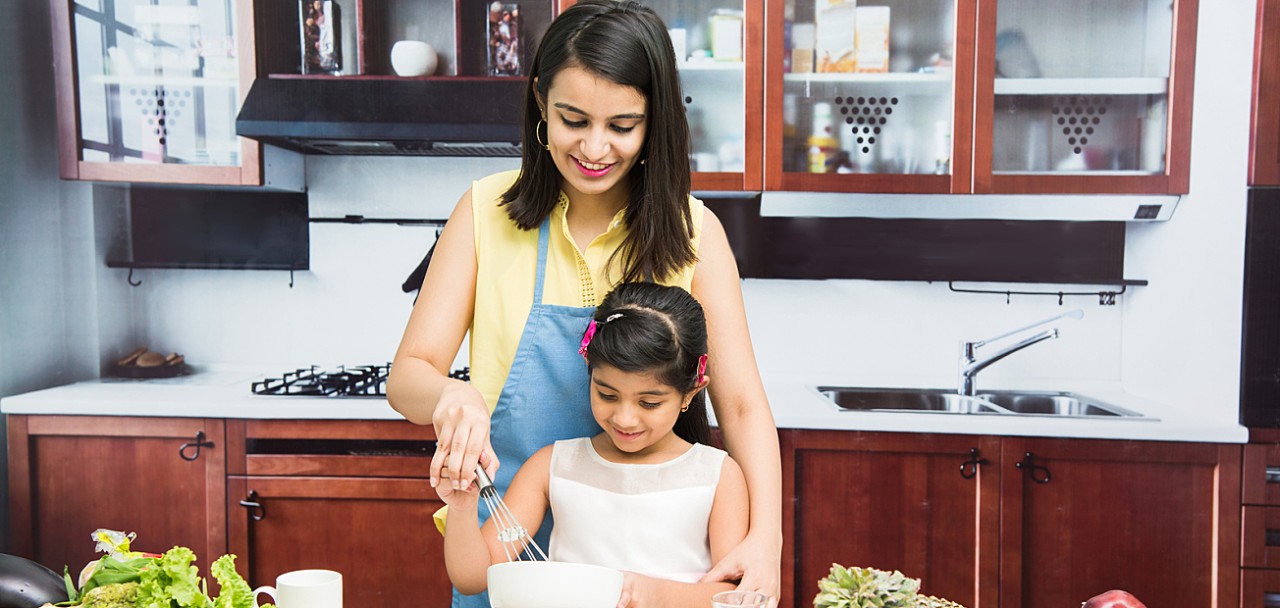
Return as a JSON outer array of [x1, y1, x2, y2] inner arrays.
[[629, 0, 764, 189]]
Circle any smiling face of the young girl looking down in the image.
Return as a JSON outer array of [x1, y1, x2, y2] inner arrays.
[[591, 365, 695, 456]]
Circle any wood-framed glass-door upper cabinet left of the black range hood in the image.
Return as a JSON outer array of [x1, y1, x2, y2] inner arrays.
[[52, 0, 261, 184]]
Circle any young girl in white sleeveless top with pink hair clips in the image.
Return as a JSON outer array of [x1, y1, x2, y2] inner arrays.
[[435, 283, 749, 608]]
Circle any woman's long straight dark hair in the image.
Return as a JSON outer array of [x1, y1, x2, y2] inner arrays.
[[502, 0, 696, 282]]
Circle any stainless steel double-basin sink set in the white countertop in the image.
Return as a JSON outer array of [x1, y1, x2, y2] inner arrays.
[[817, 387, 1156, 420]]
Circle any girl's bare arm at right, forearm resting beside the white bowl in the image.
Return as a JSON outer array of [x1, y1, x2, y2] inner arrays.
[[618, 458, 749, 608]]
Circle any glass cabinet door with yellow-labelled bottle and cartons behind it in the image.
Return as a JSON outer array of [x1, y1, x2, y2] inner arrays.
[[767, 0, 974, 192]]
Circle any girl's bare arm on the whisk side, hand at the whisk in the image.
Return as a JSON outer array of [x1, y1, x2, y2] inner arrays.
[[435, 445, 552, 595]]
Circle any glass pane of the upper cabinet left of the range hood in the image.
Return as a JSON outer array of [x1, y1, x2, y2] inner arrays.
[[64, 0, 256, 183]]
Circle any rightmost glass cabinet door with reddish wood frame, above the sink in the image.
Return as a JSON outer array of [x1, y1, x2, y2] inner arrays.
[[975, 0, 1194, 192]]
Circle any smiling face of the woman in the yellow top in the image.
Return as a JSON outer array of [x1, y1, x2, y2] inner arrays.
[[543, 67, 648, 204]]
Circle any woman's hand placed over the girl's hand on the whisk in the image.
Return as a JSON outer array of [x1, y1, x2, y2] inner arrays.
[[431, 381, 499, 498]]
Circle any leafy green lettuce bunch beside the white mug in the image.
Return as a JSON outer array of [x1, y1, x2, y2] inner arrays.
[[59, 532, 274, 608]]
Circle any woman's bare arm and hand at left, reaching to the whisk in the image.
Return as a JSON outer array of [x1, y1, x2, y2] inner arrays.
[[387, 189, 488, 489]]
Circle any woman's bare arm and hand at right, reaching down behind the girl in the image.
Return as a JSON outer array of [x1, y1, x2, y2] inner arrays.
[[692, 210, 782, 602]]
